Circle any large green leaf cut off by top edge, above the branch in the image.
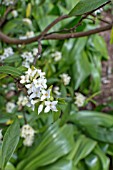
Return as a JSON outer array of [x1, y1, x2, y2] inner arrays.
[[69, 0, 108, 16]]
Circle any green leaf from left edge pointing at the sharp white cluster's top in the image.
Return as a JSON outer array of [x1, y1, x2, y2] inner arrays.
[[0, 66, 22, 76]]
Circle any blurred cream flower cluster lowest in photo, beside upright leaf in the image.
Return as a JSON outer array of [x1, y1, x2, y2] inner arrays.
[[21, 124, 35, 146]]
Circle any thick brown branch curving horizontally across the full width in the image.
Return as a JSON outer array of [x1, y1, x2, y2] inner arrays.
[[0, 23, 113, 44]]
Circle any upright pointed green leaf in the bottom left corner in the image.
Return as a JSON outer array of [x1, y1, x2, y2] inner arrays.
[[2, 118, 20, 169]]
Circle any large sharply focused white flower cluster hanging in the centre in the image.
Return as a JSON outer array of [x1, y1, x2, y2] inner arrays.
[[20, 67, 58, 114]]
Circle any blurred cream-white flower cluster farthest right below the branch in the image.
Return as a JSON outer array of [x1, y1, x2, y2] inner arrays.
[[75, 93, 86, 107]]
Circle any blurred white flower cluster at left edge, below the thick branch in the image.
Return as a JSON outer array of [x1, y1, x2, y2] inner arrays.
[[0, 47, 14, 61]]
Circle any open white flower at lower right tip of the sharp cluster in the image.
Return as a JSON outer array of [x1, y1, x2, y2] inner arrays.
[[44, 101, 58, 113]]
